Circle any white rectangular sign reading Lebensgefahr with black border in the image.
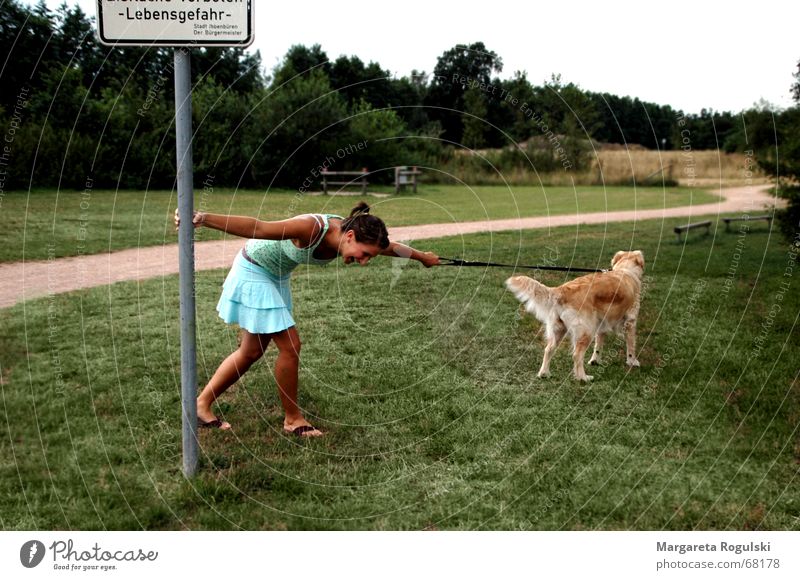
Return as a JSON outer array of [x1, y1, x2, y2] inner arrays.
[[97, 0, 253, 46]]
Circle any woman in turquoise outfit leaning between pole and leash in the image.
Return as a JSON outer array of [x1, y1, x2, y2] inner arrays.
[[175, 201, 439, 437]]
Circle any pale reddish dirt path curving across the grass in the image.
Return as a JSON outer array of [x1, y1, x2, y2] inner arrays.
[[0, 186, 775, 308]]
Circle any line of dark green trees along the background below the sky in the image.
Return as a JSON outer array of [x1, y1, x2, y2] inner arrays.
[[0, 0, 798, 195]]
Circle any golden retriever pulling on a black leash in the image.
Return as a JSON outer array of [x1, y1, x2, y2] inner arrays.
[[506, 250, 644, 381]]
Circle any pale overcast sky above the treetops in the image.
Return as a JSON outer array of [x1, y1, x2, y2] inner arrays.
[[21, 0, 800, 113]]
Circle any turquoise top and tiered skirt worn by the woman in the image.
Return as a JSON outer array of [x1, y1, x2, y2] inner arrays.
[[217, 214, 342, 334]]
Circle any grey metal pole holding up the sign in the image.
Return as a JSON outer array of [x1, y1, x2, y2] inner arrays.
[[175, 48, 198, 477]]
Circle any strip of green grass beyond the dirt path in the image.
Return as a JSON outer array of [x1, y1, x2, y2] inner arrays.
[[0, 184, 718, 262]]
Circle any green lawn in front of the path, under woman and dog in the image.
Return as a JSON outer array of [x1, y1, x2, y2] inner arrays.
[[0, 221, 800, 530]]
